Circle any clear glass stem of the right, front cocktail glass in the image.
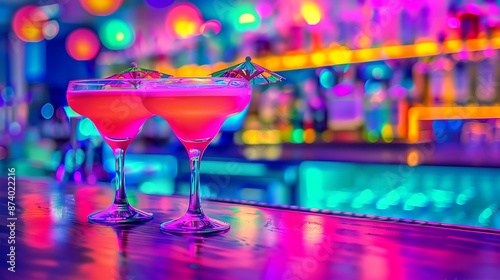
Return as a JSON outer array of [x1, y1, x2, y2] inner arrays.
[[187, 149, 203, 215]]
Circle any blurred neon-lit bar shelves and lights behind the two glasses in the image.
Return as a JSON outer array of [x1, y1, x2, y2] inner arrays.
[[0, 0, 500, 228]]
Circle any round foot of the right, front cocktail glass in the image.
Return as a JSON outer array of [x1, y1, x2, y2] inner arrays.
[[160, 213, 230, 235]]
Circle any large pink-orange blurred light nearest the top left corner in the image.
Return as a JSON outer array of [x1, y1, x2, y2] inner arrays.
[[12, 5, 49, 42]]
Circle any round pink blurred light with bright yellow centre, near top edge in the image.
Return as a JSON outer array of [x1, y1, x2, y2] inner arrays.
[[165, 4, 203, 38]]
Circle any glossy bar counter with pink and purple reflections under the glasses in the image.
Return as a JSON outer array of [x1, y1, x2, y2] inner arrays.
[[0, 178, 500, 280]]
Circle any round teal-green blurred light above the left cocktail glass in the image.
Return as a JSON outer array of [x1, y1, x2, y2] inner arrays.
[[99, 19, 135, 50]]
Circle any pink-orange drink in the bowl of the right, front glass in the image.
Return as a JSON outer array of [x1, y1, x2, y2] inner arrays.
[[143, 84, 251, 151]]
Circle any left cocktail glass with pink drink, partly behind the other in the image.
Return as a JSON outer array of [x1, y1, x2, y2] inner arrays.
[[66, 79, 153, 224]]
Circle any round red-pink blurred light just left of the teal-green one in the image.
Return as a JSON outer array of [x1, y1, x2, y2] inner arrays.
[[66, 28, 101, 60]]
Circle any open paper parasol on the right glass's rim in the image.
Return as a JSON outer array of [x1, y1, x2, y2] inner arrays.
[[210, 56, 285, 85]]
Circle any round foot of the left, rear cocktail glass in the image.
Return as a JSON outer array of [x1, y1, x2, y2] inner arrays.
[[89, 204, 153, 224]]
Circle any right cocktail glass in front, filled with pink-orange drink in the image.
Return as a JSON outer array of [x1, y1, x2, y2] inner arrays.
[[142, 77, 251, 235]]
